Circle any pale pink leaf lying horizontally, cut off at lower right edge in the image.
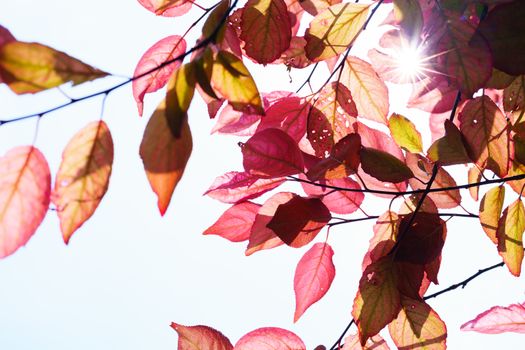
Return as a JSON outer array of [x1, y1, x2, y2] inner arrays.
[[461, 303, 525, 334]]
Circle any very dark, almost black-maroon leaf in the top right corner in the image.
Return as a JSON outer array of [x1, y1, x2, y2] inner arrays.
[[473, 1, 525, 75]]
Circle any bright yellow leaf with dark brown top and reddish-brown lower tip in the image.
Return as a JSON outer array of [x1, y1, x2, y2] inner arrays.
[[210, 51, 264, 114]]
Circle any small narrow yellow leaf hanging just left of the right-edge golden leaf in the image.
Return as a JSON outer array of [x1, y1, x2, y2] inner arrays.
[[479, 186, 505, 244]]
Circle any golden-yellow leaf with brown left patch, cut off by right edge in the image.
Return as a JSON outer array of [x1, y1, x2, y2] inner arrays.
[[496, 198, 525, 276]]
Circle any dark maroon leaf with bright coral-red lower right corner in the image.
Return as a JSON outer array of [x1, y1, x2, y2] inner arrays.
[[266, 195, 332, 248]]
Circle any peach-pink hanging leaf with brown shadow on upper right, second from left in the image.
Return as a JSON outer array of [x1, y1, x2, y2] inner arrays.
[[52, 121, 113, 243]]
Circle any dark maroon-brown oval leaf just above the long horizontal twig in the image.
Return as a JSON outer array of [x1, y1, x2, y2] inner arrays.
[[359, 147, 414, 183]]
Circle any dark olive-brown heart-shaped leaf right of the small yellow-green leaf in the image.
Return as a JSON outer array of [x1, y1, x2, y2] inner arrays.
[[427, 119, 471, 165]]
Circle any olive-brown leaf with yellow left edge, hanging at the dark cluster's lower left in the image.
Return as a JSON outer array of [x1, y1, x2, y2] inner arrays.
[[352, 257, 401, 345]]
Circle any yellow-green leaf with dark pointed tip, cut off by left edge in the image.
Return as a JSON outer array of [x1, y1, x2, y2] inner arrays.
[[0, 41, 107, 94]]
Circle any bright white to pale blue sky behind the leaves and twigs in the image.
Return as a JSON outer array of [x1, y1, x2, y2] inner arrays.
[[0, 0, 525, 350]]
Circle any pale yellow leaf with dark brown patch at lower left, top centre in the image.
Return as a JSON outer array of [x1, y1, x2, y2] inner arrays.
[[304, 3, 370, 61]]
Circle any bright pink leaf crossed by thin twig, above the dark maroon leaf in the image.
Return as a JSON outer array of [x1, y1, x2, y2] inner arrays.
[[301, 177, 365, 214]]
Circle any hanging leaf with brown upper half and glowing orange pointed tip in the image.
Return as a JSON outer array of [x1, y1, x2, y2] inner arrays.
[[140, 101, 193, 215]]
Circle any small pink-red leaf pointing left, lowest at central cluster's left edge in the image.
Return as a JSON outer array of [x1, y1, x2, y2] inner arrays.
[[203, 202, 261, 242]]
